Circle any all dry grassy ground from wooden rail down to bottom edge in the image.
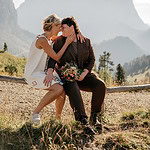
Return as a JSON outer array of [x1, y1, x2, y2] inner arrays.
[[0, 81, 150, 150]]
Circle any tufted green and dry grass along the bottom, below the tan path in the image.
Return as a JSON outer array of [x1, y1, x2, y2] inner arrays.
[[0, 102, 150, 150]]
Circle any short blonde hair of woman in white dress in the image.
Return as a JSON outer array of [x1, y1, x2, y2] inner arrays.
[[42, 14, 61, 31]]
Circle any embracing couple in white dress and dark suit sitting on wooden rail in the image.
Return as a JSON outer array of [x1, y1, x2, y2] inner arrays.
[[24, 15, 106, 134]]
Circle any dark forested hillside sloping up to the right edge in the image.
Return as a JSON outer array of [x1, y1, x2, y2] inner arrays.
[[123, 55, 150, 76]]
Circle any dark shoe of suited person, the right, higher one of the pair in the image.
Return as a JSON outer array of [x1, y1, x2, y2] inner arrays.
[[90, 113, 102, 134]]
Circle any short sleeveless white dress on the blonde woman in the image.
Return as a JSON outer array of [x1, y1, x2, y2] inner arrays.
[[24, 35, 63, 89]]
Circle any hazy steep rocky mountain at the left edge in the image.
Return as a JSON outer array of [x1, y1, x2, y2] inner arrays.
[[0, 0, 34, 56]]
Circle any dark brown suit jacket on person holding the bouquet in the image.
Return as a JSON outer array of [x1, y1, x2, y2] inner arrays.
[[48, 36, 95, 72]]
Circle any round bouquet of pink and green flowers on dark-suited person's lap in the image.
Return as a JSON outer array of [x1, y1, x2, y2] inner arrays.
[[60, 62, 83, 82]]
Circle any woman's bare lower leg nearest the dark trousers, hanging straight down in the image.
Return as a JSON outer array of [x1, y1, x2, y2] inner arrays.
[[55, 90, 66, 119]]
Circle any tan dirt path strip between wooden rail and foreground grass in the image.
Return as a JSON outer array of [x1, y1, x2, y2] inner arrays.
[[0, 81, 150, 120]]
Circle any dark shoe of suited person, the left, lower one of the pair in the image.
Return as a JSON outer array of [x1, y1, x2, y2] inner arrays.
[[81, 118, 95, 135]]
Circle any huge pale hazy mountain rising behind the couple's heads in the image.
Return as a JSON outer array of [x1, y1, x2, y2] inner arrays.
[[17, 0, 149, 43]]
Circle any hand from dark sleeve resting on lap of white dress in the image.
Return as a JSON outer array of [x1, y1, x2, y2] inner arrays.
[[43, 68, 55, 87]]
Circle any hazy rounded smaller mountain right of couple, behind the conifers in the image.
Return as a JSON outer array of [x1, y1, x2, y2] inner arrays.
[[93, 36, 144, 65]]
